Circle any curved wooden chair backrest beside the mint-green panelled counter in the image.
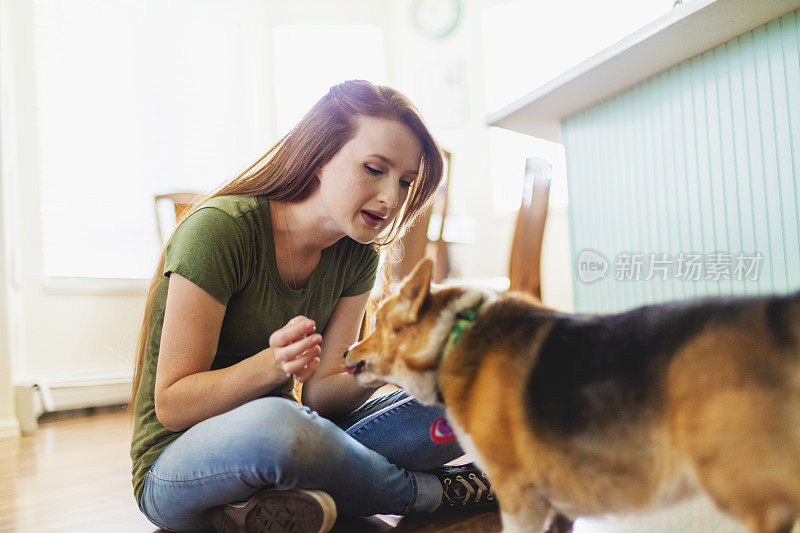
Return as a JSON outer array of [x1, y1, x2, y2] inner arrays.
[[508, 157, 552, 300]]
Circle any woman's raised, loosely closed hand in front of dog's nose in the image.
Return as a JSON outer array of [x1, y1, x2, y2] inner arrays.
[[269, 315, 322, 383]]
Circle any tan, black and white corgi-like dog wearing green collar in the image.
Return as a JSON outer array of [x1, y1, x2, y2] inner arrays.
[[344, 259, 800, 533]]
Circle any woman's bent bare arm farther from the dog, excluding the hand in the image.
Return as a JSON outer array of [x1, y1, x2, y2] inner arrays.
[[155, 272, 300, 431]]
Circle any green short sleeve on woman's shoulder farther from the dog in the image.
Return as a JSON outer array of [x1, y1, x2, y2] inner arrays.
[[163, 207, 248, 305]]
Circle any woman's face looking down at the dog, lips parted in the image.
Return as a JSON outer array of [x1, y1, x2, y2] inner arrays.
[[317, 116, 422, 243]]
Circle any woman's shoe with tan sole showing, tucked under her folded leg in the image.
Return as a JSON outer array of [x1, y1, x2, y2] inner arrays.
[[209, 489, 336, 533]]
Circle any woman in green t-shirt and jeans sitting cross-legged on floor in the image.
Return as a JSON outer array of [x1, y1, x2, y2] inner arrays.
[[131, 81, 491, 531]]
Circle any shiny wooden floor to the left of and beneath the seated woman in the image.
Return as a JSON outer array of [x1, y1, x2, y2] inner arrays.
[[0, 408, 501, 533]]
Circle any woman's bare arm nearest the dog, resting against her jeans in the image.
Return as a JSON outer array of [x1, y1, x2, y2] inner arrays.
[[303, 293, 378, 418]]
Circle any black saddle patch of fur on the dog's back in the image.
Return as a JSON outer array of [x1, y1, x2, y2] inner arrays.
[[525, 293, 800, 437]]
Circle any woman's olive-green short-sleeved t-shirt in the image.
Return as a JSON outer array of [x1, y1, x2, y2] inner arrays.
[[131, 196, 378, 502]]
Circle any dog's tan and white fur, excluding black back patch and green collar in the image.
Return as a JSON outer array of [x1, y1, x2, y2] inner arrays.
[[346, 260, 800, 533]]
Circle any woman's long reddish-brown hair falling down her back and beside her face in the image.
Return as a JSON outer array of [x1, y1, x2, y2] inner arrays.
[[129, 80, 444, 413]]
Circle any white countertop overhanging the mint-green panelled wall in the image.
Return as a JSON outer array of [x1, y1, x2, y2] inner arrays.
[[486, 0, 800, 141]]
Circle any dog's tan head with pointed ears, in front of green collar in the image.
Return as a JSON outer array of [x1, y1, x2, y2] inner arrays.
[[345, 258, 476, 404]]
